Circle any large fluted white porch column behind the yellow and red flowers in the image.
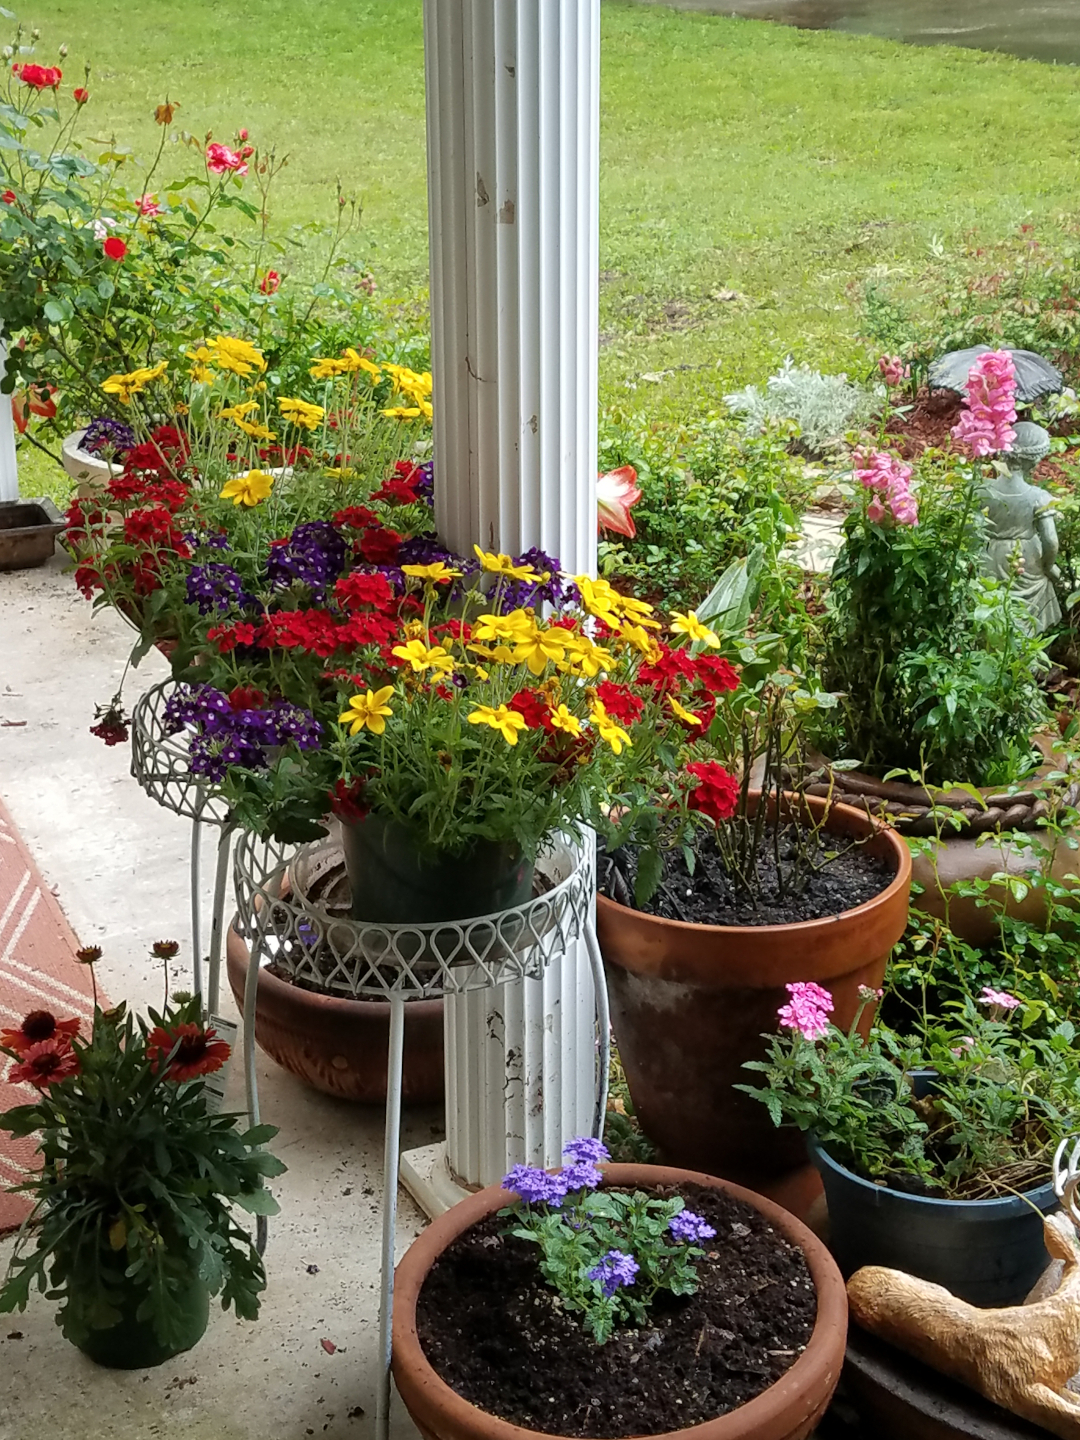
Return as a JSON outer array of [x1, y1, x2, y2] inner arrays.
[[423, 0, 599, 1185]]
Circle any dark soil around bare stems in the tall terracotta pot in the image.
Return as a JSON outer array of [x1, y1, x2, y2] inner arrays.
[[599, 829, 896, 924]]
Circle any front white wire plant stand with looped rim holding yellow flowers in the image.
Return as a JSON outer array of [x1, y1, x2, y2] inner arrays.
[[233, 832, 596, 1440]]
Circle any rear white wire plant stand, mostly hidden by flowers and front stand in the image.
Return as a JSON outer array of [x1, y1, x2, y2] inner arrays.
[[131, 680, 234, 1013]]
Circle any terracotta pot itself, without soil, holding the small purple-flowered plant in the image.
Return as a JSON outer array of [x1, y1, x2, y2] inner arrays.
[[393, 1165, 848, 1440]]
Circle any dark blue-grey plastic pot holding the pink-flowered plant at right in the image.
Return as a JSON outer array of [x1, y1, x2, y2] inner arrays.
[[808, 1136, 1057, 1309]]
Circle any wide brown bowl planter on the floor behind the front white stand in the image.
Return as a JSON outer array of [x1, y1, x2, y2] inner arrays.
[[226, 927, 444, 1104]]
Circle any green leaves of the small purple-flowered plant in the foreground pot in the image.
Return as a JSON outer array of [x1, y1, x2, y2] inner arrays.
[[500, 1189, 704, 1345]]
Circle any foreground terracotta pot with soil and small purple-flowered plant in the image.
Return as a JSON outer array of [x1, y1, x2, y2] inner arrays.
[[393, 1138, 847, 1440]]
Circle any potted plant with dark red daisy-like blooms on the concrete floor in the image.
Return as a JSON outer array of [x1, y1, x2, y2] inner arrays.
[[0, 942, 285, 1369]]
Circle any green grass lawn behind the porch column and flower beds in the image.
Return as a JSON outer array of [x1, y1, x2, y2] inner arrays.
[[22, 0, 1080, 413]]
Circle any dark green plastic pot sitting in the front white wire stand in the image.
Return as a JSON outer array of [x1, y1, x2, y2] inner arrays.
[[341, 815, 533, 924]]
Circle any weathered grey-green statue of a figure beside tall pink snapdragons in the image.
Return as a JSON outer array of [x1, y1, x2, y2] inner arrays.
[[982, 420, 1061, 631]]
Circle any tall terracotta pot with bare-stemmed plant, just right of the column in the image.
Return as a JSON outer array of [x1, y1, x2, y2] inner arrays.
[[598, 632, 910, 1204]]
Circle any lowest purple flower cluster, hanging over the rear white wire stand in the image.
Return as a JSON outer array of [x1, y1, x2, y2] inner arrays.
[[164, 685, 323, 782]]
